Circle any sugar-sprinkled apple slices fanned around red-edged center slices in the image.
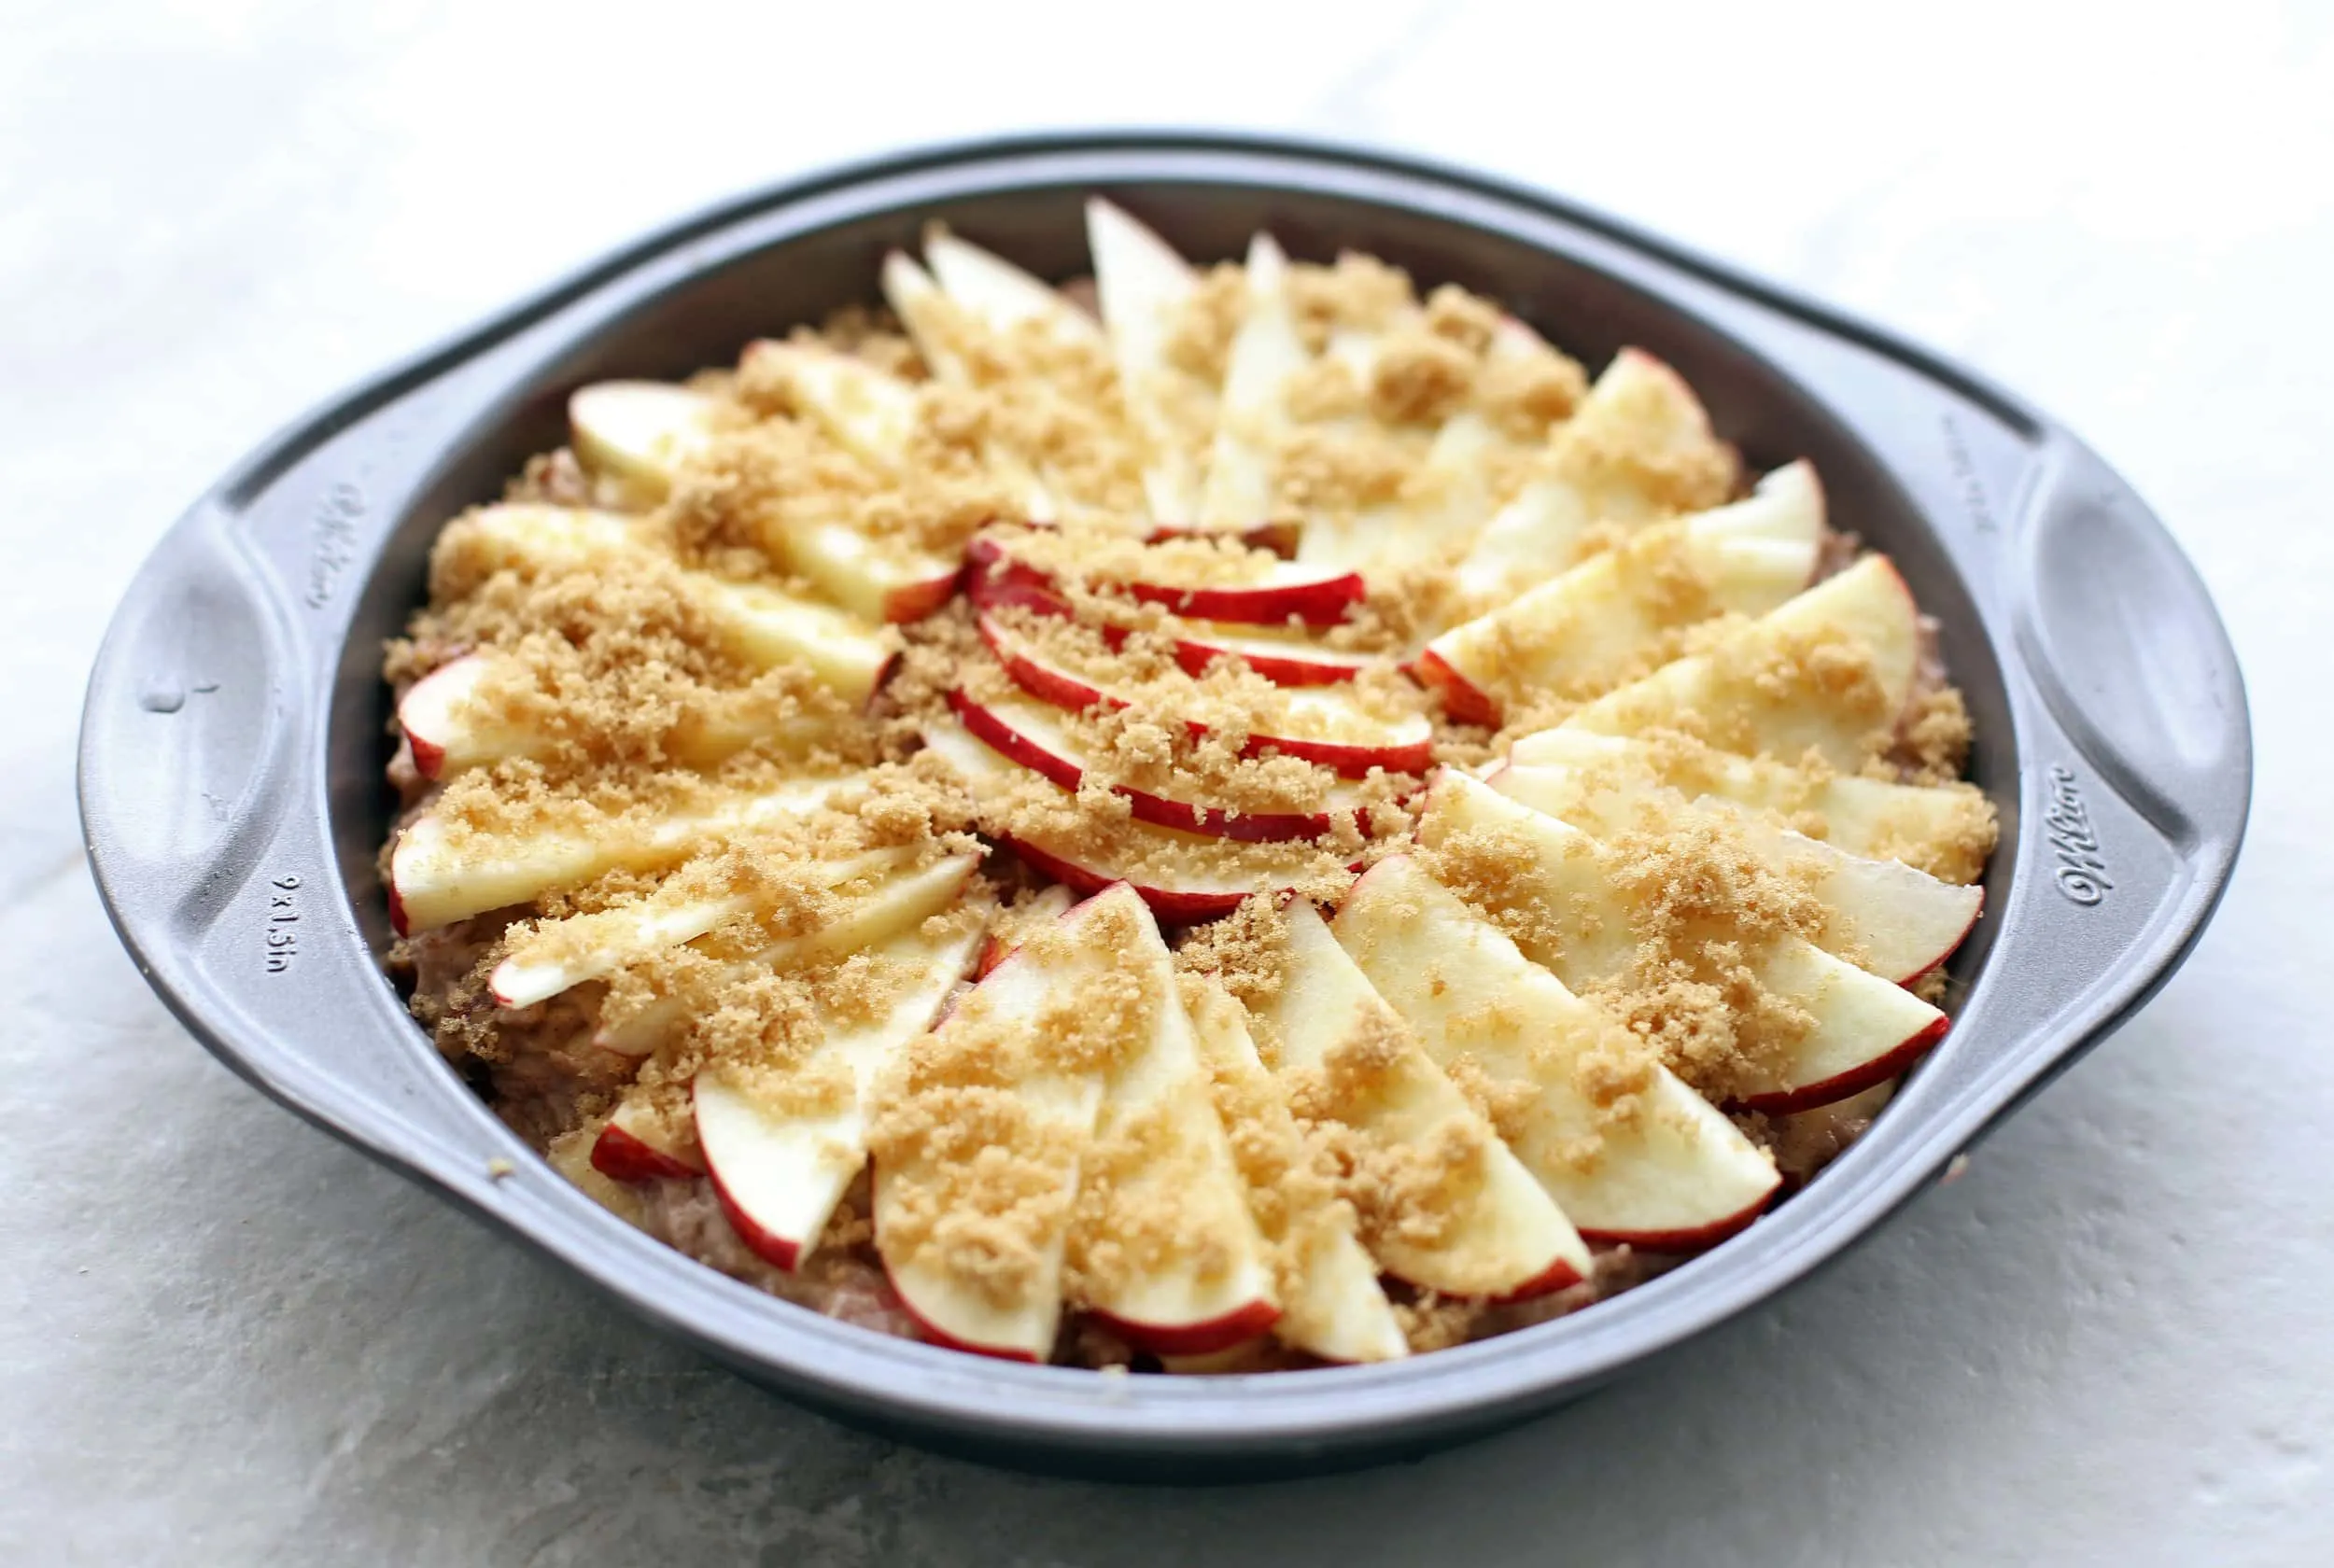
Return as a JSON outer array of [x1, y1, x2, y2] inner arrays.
[[383, 201, 1993, 1370]]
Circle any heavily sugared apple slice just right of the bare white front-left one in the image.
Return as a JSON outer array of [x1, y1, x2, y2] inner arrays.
[[868, 887, 1174, 1363]]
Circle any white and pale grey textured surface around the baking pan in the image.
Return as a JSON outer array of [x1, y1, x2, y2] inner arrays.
[[0, 0, 2334, 1566]]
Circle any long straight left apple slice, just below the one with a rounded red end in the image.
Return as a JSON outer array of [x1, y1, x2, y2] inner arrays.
[[390, 775, 864, 936]]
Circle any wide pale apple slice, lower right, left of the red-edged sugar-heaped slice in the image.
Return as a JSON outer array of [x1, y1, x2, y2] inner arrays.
[[1330, 854, 1783, 1251]]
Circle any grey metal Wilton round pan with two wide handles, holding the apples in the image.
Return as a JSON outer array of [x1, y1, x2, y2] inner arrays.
[[82, 133, 2253, 1479]]
